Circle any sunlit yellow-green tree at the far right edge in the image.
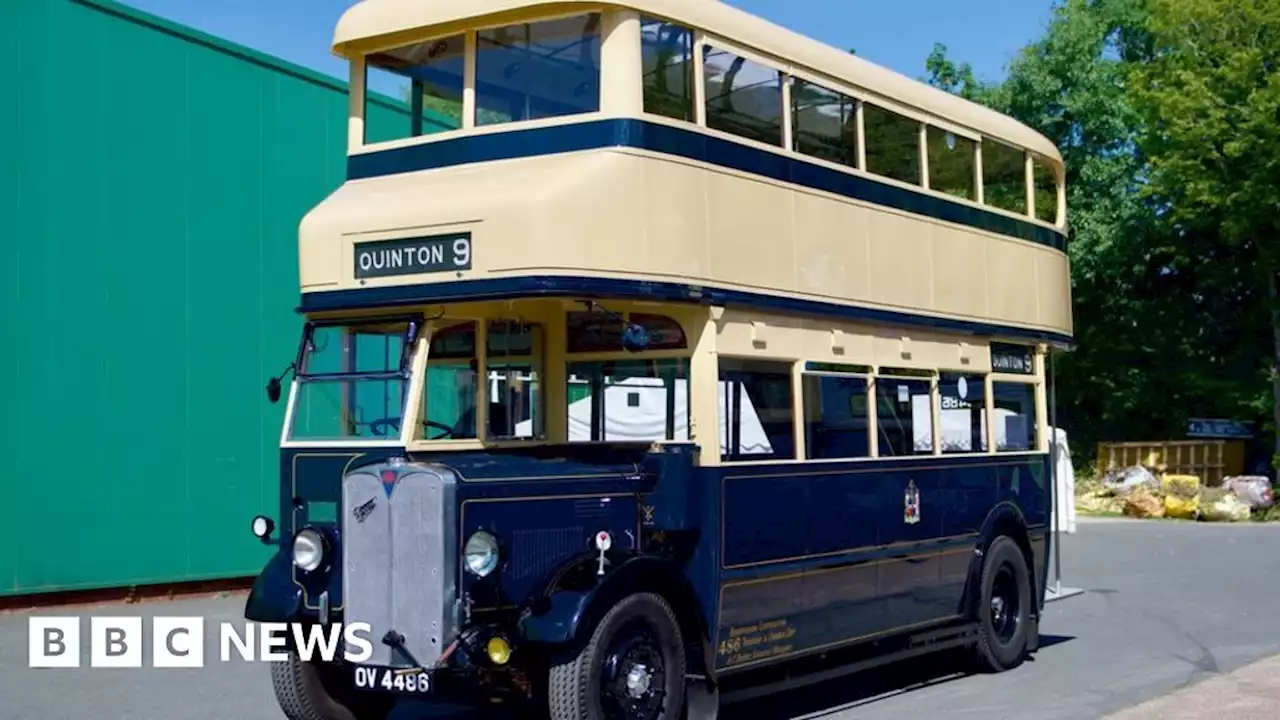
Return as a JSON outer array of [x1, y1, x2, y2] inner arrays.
[[1133, 0, 1280, 452]]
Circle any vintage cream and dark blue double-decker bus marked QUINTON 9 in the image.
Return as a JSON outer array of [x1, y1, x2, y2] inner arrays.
[[246, 0, 1071, 720]]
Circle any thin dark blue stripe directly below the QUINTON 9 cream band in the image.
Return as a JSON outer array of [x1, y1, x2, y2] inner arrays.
[[297, 275, 1074, 347]]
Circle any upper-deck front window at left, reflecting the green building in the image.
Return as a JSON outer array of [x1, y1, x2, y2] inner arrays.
[[365, 35, 463, 143]]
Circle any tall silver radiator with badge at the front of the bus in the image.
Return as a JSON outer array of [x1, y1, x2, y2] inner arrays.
[[340, 464, 460, 667]]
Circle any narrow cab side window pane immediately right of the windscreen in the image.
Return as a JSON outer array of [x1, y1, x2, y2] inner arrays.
[[417, 322, 477, 439]]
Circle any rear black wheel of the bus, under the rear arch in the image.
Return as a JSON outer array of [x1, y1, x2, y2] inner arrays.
[[973, 536, 1032, 673]]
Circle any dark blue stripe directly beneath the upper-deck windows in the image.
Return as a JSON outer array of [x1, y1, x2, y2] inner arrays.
[[347, 118, 1066, 252]]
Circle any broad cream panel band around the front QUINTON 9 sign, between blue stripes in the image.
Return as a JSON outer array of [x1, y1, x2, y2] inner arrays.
[[300, 149, 1071, 334]]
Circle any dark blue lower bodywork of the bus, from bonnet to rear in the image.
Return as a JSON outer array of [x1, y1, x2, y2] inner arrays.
[[246, 445, 1051, 673]]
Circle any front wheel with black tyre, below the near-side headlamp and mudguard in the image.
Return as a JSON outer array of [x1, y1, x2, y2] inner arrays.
[[547, 593, 685, 720]]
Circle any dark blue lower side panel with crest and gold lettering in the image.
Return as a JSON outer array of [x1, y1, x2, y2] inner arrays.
[[716, 456, 1047, 669]]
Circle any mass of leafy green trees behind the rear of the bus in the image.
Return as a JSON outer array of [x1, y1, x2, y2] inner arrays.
[[925, 0, 1280, 461]]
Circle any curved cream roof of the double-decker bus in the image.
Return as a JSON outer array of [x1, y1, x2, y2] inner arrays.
[[333, 0, 1062, 167]]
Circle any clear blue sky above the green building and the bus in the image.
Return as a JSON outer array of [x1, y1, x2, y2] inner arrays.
[[122, 0, 1053, 79]]
